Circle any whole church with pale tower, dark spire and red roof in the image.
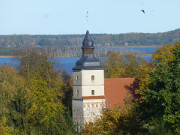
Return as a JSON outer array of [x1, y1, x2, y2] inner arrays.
[[72, 30, 138, 126]]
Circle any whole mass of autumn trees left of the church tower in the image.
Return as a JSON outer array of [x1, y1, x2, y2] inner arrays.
[[0, 53, 75, 134]]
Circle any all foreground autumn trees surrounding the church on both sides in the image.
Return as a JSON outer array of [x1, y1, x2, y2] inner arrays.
[[0, 41, 180, 135]]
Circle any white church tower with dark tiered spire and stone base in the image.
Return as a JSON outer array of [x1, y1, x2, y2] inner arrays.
[[72, 30, 106, 127]]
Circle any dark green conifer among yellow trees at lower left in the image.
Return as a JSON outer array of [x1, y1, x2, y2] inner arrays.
[[7, 89, 32, 134]]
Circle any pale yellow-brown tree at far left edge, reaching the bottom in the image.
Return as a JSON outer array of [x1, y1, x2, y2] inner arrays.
[[0, 65, 25, 134]]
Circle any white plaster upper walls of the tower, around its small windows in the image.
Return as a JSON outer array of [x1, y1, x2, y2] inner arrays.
[[73, 70, 104, 99]]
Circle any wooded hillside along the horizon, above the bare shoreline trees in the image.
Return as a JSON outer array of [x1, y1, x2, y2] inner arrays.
[[0, 29, 180, 48]]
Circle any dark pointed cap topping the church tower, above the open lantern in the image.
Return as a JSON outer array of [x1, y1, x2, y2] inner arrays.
[[81, 30, 94, 49]]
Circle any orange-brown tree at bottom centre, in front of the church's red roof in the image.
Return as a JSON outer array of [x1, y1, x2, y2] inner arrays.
[[82, 102, 141, 134]]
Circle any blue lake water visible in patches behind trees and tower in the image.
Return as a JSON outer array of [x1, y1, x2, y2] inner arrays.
[[0, 46, 159, 75]]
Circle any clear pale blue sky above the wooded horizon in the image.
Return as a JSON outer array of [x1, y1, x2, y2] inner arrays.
[[0, 0, 180, 35]]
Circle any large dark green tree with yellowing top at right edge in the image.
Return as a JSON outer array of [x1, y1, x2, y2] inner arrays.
[[138, 42, 180, 133]]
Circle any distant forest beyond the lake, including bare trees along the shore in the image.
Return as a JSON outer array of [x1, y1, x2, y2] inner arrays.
[[0, 29, 180, 57]]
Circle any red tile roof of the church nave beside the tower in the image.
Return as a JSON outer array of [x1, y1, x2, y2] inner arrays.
[[104, 78, 139, 108]]
